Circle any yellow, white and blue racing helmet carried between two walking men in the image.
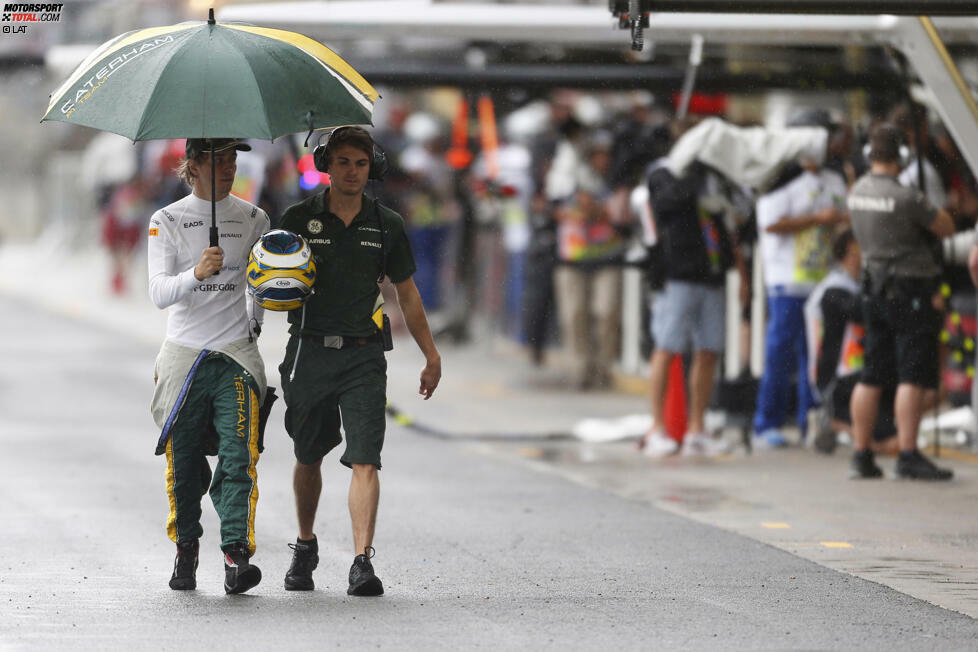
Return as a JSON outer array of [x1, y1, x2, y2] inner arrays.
[[248, 229, 316, 311]]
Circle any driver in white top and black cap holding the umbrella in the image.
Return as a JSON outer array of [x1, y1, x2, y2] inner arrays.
[[149, 139, 273, 593]]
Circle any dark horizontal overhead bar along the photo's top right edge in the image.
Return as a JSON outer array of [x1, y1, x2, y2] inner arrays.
[[643, 0, 978, 16]]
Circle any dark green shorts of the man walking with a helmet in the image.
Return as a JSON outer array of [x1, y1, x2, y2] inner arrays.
[[278, 335, 387, 469]]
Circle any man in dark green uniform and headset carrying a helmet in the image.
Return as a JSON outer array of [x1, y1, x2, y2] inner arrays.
[[279, 127, 441, 595]]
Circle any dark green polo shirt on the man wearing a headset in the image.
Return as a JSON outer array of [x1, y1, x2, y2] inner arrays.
[[279, 190, 417, 337]]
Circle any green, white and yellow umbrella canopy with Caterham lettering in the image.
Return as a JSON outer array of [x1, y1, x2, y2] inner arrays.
[[42, 16, 379, 141]]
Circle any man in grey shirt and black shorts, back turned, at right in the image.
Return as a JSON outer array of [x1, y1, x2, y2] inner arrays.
[[848, 124, 954, 480]]
